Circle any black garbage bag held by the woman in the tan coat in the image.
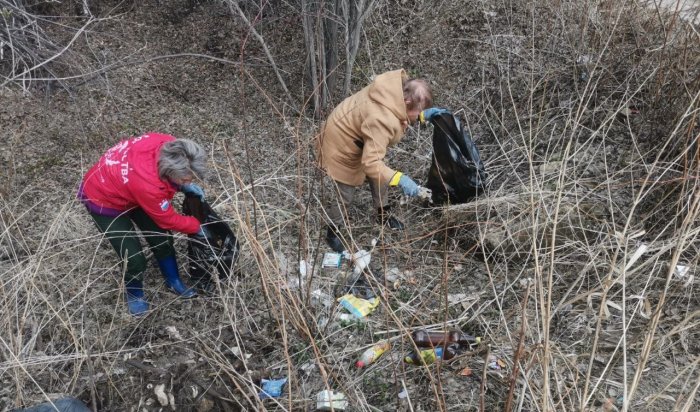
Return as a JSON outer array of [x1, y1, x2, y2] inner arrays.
[[425, 113, 487, 204]]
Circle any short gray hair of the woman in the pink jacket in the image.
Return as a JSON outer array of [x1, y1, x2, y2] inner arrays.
[[158, 139, 207, 180]]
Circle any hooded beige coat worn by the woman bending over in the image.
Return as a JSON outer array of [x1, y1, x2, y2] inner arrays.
[[317, 70, 408, 186]]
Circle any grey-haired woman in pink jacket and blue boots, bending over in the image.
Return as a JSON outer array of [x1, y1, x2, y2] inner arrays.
[[78, 133, 206, 315]]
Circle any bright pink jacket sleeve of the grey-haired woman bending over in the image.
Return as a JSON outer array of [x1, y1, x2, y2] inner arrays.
[[133, 186, 199, 235]]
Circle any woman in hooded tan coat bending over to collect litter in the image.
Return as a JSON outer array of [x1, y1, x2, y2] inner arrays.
[[318, 70, 432, 252]]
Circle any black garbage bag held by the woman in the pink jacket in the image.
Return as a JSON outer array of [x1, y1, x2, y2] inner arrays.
[[182, 194, 240, 292]]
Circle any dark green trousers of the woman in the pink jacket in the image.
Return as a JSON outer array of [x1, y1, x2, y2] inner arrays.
[[90, 209, 175, 282]]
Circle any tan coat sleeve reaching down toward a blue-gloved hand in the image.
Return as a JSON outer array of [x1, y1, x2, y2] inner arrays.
[[362, 112, 403, 185]]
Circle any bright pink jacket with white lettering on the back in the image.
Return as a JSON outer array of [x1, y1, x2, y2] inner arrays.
[[81, 133, 199, 234]]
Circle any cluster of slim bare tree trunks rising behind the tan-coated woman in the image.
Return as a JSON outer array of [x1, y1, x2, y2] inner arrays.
[[301, 0, 377, 116]]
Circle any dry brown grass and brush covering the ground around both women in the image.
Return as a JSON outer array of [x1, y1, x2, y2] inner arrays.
[[0, 0, 700, 411]]
